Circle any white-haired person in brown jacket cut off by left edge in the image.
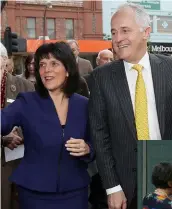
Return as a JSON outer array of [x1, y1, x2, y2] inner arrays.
[[0, 43, 34, 209]]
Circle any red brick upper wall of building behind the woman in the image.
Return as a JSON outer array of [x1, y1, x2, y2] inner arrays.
[[2, 1, 103, 39]]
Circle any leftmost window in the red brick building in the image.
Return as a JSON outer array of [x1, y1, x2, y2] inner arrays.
[[27, 17, 36, 38]]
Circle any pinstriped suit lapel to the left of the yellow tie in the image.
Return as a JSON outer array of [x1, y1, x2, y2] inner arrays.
[[112, 60, 137, 139]]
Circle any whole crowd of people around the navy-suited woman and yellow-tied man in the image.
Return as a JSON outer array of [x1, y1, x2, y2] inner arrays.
[[0, 3, 172, 209]]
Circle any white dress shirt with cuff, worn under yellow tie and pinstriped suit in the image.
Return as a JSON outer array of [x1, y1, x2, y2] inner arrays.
[[106, 52, 161, 195]]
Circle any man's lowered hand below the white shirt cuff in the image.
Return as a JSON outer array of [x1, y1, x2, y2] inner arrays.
[[107, 191, 127, 209]]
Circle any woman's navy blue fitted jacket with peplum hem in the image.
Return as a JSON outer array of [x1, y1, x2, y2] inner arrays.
[[1, 92, 94, 192]]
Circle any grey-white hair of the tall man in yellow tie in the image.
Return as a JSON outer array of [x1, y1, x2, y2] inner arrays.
[[115, 3, 151, 31]]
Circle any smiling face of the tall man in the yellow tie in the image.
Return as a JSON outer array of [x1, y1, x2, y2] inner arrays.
[[111, 8, 150, 63]]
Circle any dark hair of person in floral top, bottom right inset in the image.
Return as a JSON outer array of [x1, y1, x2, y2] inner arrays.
[[152, 162, 172, 189]]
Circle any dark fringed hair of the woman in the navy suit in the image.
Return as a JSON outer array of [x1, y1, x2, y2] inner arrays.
[[34, 42, 80, 97]]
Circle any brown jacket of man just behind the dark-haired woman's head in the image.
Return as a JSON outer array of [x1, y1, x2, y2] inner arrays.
[[78, 57, 93, 76]]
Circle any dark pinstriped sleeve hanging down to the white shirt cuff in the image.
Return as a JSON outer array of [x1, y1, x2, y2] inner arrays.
[[89, 72, 120, 189]]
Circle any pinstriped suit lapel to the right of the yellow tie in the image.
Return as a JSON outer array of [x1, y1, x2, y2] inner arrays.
[[150, 54, 166, 138]]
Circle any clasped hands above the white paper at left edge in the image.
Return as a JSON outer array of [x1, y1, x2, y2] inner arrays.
[[3, 128, 23, 150]]
